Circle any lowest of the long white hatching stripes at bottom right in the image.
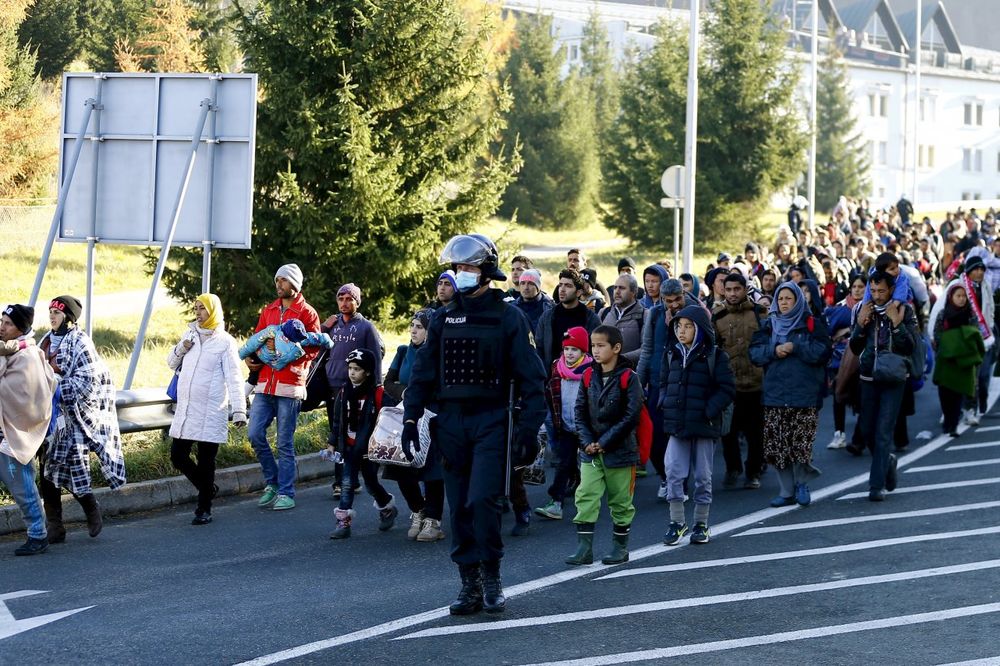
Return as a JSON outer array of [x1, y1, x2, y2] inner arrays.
[[526, 603, 1000, 666]]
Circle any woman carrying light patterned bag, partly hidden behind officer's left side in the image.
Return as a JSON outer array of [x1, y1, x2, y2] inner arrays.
[[382, 310, 445, 542]]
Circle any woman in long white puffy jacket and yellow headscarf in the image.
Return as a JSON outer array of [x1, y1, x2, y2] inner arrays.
[[167, 294, 247, 525]]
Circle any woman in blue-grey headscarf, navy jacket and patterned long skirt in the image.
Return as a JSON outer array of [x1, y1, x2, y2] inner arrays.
[[750, 282, 831, 507]]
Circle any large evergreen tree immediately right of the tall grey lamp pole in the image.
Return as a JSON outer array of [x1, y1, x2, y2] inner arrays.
[[695, 0, 806, 242]]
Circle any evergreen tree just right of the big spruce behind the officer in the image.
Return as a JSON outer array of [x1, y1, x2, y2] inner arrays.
[[500, 14, 600, 229]]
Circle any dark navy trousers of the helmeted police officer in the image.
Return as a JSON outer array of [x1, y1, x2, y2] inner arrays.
[[436, 407, 507, 564]]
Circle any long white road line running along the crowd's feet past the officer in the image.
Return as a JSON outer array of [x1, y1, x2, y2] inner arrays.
[[236, 377, 1000, 666]]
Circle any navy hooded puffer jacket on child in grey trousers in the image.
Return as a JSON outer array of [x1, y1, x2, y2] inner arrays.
[[657, 305, 736, 439]]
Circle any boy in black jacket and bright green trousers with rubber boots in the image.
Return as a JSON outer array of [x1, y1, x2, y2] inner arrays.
[[566, 326, 643, 564]]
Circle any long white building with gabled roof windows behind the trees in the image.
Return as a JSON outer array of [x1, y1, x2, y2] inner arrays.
[[503, 0, 1000, 207]]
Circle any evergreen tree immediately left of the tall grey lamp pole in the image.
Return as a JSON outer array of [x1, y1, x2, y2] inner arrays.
[[603, 20, 688, 248]]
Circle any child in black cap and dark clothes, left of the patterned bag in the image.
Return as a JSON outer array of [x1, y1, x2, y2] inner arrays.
[[327, 348, 399, 539]]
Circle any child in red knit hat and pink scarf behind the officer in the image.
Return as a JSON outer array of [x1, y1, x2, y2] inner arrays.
[[535, 326, 594, 520]]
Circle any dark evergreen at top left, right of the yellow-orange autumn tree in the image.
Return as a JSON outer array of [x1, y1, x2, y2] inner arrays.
[[17, 0, 81, 79]]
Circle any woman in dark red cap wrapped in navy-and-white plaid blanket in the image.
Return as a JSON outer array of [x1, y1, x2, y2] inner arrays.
[[39, 296, 125, 543]]
